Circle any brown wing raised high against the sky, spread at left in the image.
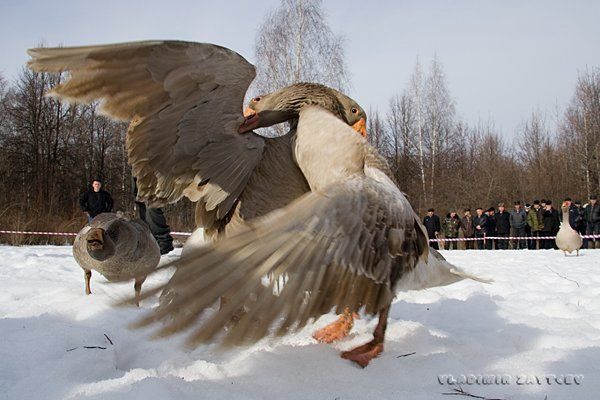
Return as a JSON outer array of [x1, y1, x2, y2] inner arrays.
[[28, 41, 264, 218]]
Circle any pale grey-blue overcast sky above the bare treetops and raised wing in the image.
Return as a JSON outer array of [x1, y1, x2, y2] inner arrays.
[[0, 0, 600, 138]]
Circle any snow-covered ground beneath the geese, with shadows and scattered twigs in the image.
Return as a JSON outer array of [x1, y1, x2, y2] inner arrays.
[[0, 246, 600, 400]]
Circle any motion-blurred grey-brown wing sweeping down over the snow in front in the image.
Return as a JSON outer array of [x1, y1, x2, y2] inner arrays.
[[131, 176, 427, 344]]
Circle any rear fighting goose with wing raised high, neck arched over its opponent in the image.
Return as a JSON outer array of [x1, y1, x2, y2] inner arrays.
[[27, 41, 367, 338]]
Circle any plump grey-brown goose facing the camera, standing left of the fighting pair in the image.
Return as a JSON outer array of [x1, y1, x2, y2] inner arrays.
[[73, 213, 160, 306]]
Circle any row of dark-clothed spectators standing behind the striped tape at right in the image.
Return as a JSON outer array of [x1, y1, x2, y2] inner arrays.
[[423, 195, 600, 250]]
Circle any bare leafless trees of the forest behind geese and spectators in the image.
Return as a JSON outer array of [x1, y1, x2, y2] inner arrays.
[[0, 0, 600, 244]]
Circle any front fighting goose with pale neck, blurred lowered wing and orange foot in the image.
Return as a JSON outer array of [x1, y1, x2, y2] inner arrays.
[[132, 102, 488, 367]]
